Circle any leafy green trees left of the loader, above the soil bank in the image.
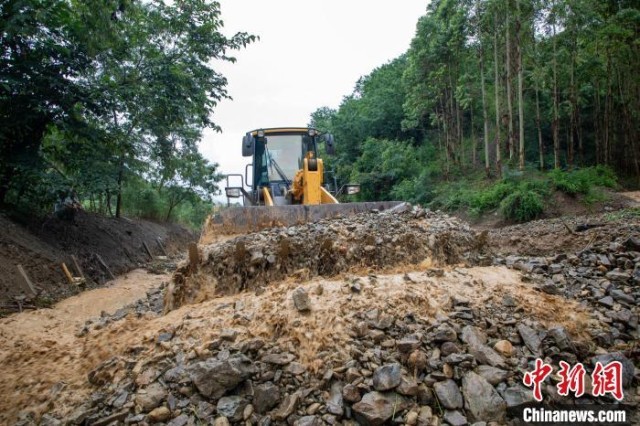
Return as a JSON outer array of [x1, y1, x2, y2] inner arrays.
[[0, 0, 255, 226]]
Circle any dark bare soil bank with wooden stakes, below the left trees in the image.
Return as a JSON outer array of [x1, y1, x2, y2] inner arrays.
[[0, 212, 197, 312]]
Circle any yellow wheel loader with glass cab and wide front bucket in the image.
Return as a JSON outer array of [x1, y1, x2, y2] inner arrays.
[[203, 127, 400, 238]]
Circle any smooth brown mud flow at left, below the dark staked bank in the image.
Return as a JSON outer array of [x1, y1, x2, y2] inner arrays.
[[0, 269, 169, 424]]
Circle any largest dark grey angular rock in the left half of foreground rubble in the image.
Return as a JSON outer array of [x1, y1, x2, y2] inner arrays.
[[187, 355, 256, 399]]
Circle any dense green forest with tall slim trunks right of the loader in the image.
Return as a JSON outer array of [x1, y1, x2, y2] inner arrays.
[[311, 0, 640, 219]]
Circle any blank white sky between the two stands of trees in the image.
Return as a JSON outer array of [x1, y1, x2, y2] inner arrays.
[[200, 0, 428, 201]]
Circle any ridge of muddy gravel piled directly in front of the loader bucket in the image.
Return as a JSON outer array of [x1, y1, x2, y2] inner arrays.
[[167, 206, 484, 310]]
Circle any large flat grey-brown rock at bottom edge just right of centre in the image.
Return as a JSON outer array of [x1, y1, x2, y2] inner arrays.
[[353, 391, 410, 426]]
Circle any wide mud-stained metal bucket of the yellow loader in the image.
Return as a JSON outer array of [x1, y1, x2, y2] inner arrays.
[[200, 201, 403, 244]]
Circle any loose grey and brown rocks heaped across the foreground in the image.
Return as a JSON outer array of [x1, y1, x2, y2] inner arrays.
[[38, 286, 638, 426]]
